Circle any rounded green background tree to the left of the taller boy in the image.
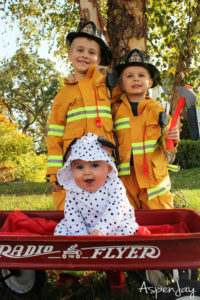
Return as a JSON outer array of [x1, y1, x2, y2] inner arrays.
[[0, 49, 60, 152]]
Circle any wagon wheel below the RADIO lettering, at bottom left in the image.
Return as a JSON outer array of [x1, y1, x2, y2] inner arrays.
[[1, 269, 46, 295]]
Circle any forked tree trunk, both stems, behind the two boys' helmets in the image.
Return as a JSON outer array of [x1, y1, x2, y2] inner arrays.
[[76, 0, 147, 64]]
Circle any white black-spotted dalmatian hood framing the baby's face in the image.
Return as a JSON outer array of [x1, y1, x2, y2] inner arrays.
[[57, 133, 118, 192]]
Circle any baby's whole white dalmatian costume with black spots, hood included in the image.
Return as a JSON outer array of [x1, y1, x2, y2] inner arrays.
[[54, 133, 138, 235]]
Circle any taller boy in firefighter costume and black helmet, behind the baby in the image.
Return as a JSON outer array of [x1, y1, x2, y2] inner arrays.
[[47, 22, 113, 210]]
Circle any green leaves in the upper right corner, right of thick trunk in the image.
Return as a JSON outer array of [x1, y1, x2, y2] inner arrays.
[[147, 0, 200, 93]]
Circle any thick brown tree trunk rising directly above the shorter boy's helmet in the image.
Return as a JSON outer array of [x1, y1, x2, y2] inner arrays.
[[107, 0, 147, 65]]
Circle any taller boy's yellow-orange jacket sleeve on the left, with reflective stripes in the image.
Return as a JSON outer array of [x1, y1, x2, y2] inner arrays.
[[47, 88, 66, 178]]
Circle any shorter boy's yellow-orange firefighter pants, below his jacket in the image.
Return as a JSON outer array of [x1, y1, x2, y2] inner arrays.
[[120, 166, 173, 209]]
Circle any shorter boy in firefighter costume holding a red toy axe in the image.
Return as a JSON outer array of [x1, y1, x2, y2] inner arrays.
[[112, 49, 179, 209]]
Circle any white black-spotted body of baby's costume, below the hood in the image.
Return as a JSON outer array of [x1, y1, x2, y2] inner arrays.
[[55, 178, 138, 235]]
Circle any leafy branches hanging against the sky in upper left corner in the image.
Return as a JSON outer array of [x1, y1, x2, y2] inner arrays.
[[1, 0, 80, 59]]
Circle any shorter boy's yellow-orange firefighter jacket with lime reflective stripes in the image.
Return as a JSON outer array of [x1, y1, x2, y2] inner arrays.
[[112, 95, 173, 200]]
